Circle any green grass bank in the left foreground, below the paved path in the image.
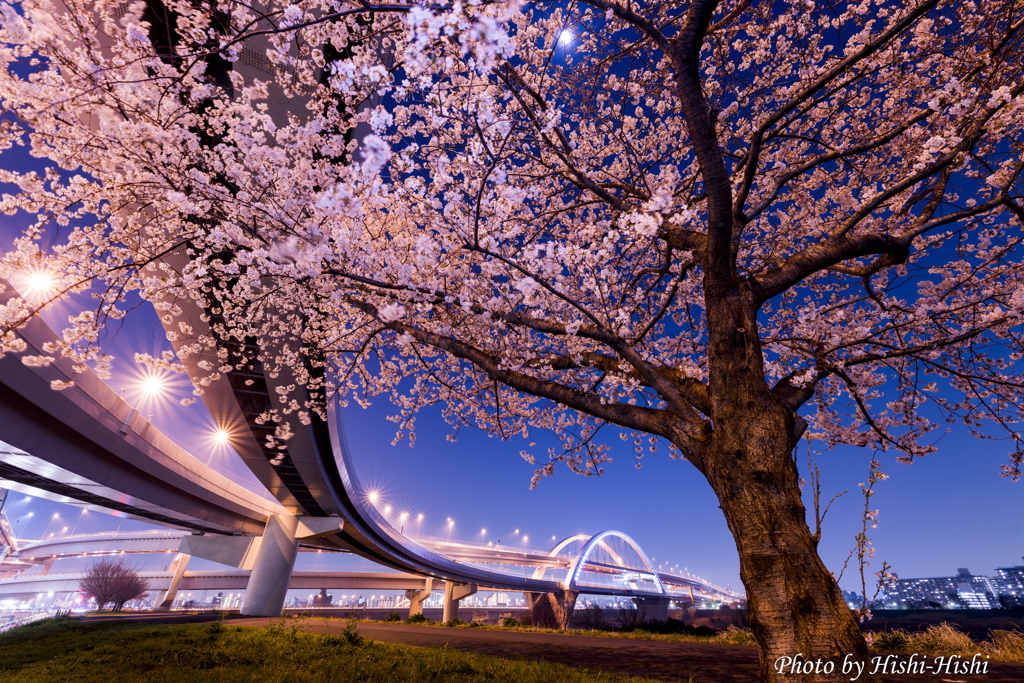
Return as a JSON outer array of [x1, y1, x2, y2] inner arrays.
[[0, 618, 652, 683]]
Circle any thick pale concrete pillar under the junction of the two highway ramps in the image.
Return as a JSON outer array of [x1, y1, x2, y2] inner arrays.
[[240, 515, 299, 616]]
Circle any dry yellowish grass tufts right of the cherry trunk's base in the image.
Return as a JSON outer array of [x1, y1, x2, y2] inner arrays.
[[871, 623, 1024, 663]]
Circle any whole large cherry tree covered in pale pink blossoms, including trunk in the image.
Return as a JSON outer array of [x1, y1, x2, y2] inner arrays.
[[0, 0, 1024, 680]]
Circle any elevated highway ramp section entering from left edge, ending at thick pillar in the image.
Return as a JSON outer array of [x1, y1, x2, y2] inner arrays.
[[0, 281, 285, 535]]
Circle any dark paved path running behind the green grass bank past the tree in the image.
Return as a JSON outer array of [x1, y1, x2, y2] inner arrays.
[[75, 614, 1024, 683]]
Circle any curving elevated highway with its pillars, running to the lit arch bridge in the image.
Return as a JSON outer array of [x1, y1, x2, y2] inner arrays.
[[0, 278, 745, 623]]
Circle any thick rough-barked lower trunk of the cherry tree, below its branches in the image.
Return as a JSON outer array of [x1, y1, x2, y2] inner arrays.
[[701, 409, 870, 682]]
